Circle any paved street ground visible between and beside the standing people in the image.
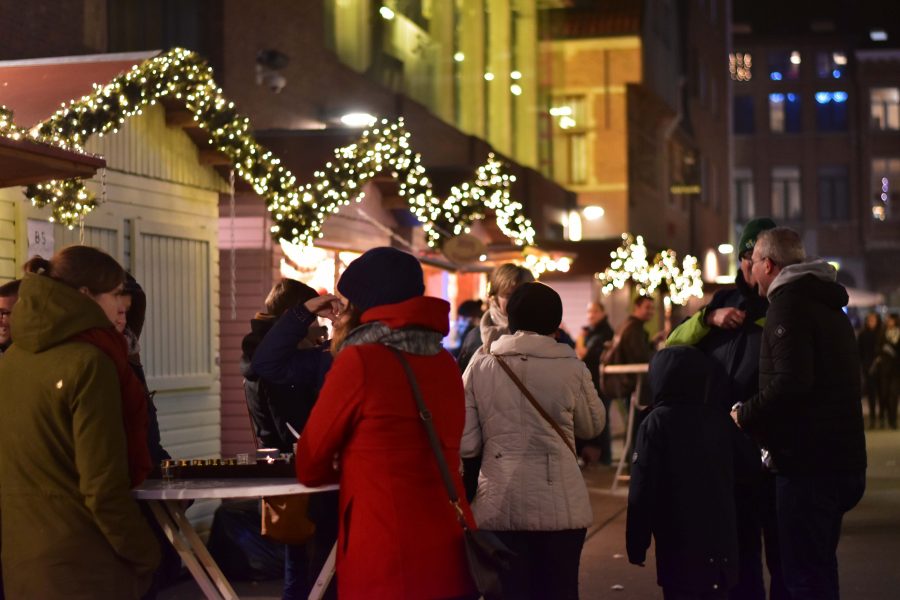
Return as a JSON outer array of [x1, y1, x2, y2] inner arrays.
[[160, 431, 900, 600]]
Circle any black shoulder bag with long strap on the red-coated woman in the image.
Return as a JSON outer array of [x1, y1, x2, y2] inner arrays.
[[388, 346, 515, 600]]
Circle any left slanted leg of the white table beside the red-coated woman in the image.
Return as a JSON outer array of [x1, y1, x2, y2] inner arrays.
[[149, 500, 238, 600]]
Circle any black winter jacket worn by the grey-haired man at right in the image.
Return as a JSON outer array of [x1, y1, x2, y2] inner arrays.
[[738, 261, 866, 475]]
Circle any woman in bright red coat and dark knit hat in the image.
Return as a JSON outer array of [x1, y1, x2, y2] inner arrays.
[[297, 248, 476, 600]]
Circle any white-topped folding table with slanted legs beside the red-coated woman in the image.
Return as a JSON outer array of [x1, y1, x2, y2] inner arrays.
[[133, 478, 338, 600]]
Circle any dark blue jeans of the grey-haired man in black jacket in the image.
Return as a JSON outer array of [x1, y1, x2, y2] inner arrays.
[[775, 470, 866, 600]]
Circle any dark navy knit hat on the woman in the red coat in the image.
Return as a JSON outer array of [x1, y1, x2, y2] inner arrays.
[[337, 247, 425, 311]]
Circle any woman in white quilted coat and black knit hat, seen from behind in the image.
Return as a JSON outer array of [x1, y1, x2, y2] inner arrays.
[[460, 283, 606, 599]]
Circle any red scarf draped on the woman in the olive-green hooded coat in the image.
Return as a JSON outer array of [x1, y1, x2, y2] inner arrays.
[[72, 326, 153, 487]]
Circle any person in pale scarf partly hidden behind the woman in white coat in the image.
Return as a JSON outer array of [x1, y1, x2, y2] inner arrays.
[[457, 263, 534, 373]]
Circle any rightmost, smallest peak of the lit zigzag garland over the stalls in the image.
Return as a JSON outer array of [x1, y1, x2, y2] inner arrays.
[[434, 152, 534, 246]]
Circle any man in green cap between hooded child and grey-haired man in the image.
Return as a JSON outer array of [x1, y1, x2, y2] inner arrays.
[[666, 217, 788, 600]]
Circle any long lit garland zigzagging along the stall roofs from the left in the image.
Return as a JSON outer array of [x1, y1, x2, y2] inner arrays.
[[9, 48, 534, 248]]
